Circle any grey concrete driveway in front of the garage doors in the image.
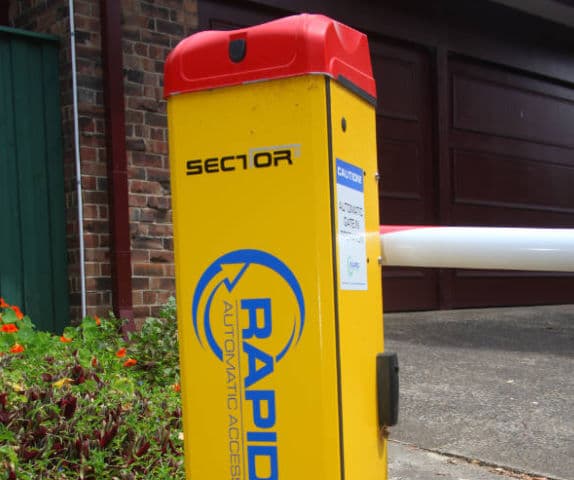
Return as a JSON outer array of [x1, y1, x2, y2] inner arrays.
[[385, 305, 574, 480]]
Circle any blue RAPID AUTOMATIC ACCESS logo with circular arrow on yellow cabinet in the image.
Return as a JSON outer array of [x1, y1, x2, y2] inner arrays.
[[192, 250, 305, 480]]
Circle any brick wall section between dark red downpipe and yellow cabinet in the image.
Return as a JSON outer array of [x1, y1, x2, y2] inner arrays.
[[122, 0, 197, 318]]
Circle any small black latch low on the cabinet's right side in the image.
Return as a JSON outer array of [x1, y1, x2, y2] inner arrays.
[[377, 353, 399, 429]]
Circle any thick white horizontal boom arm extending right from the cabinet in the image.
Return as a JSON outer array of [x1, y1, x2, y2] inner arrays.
[[380, 226, 574, 272]]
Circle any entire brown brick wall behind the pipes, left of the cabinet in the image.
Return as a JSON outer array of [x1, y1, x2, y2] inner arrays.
[[10, 0, 201, 318]]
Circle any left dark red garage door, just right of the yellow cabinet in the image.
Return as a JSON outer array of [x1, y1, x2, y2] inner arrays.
[[369, 38, 439, 311]]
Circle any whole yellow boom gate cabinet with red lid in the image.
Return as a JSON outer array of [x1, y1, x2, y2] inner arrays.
[[165, 15, 398, 480]]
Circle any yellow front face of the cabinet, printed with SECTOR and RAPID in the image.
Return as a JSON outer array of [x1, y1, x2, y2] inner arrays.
[[168, 76, 340, 480]]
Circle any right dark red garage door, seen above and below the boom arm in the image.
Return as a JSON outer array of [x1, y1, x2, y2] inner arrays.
[[440, 58, 574, 307]]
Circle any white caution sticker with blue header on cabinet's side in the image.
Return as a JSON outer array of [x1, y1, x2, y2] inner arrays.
[[336, 159, 368, 290]]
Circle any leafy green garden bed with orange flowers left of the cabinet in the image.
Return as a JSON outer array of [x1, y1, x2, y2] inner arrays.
[[0, 301, 185, 480]]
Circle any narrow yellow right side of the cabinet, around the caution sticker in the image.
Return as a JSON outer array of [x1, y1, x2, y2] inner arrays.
[[330, 82, 387, 480]]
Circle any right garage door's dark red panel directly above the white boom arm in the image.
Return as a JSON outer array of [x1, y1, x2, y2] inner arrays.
[[452, 149, 574, 214]]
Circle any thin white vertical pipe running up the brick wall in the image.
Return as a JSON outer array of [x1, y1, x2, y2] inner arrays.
[[68, 0, 86, 318]]
